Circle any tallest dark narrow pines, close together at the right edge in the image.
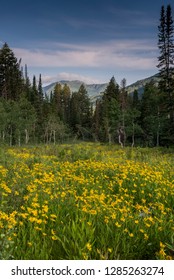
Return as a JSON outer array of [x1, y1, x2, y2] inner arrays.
[[157, 5, 174, 140]]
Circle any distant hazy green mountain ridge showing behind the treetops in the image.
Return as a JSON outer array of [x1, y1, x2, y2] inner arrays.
[[43, 74, 159, 103]]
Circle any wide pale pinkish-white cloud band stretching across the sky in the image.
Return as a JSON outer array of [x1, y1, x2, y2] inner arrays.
[[14, 40, 157, 70]]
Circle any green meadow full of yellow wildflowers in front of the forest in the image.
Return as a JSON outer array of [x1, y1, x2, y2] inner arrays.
[[0, 143, 174, 260]]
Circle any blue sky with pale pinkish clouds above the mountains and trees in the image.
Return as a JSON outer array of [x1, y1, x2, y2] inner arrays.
[[0, 0, 171, 85]]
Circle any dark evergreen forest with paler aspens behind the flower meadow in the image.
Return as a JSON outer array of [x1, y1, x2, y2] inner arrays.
[[0, 5, 174, 147]]
